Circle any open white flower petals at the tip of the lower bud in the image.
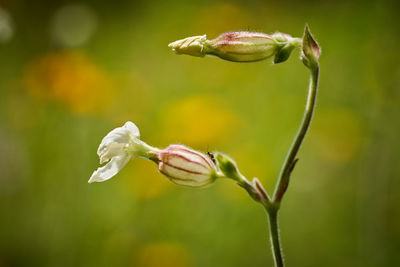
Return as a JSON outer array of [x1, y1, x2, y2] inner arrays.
[[89, 121, 151, 183]]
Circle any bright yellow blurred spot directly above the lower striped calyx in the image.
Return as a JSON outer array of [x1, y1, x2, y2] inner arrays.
[[160, 96, 238, 147]]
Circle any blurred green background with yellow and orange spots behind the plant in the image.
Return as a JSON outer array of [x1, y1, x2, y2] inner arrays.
[[0, 0, 400, 267]]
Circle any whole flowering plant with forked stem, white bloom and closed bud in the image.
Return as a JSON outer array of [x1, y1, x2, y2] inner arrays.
[[89, 26, 321, 267]]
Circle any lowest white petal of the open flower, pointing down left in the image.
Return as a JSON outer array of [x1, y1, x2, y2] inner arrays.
[[88, 153, 131, 183]]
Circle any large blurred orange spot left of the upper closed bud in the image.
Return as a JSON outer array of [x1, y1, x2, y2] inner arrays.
[[24, 52, 114, 114]]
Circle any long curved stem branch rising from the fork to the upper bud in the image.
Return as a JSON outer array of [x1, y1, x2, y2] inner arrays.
[[272, 64, 319, 204]]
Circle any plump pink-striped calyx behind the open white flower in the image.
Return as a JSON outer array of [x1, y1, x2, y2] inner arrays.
[[158, 145, 217, 187]]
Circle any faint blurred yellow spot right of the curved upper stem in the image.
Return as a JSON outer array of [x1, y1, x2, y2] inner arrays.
[[310, 108, 364, 163]]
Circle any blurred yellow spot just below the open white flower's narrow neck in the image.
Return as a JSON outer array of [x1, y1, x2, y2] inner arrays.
[[121, 159, 173, 200]]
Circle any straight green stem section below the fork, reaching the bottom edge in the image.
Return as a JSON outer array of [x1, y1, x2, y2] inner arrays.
[[266, 208, 285, 267]]
